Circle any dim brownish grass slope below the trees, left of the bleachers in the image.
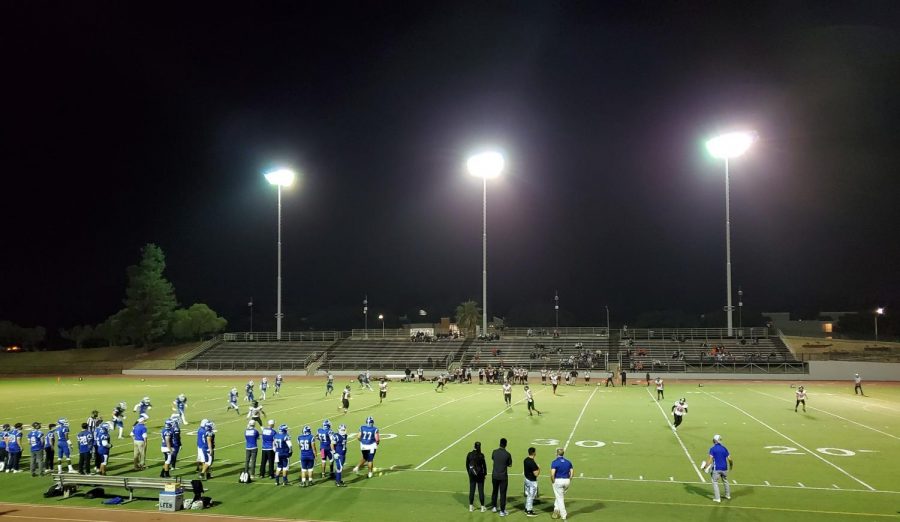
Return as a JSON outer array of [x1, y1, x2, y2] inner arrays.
[[0, 343, 199, 375]]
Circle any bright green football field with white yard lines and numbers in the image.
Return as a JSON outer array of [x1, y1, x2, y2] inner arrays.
[[0, 375, 900, 521]]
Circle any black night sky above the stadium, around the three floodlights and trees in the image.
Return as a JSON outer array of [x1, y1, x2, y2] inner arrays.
[[0, 0, 900, 331]]
